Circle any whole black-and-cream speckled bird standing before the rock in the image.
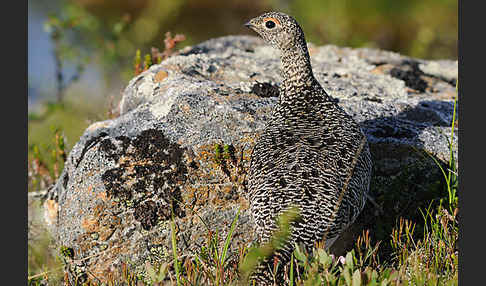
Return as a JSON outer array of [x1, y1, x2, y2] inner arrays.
[[246, 12, 372, 281]]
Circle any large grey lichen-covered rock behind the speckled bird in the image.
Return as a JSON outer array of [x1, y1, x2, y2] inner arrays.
[[40, 36, 457, 280]]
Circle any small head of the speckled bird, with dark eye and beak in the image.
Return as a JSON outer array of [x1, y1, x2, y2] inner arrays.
[[245, 12, 305, 51]]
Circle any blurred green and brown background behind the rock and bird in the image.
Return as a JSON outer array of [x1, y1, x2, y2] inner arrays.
[[28, 0, 458, 190]]
